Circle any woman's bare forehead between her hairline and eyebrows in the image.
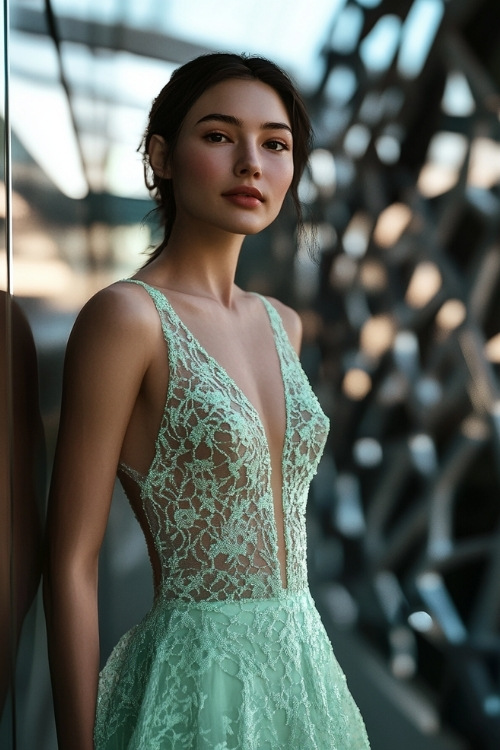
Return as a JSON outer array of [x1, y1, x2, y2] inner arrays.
[[185, 78, 291, 126]]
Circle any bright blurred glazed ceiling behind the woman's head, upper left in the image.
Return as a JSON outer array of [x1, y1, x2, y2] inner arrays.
[[11, 0, 343, 198]]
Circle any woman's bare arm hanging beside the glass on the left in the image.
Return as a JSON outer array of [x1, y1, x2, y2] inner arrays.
[[44, 285, 155, 750]]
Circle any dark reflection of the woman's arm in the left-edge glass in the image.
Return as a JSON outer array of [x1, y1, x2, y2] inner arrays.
[[0, 290, 44, 736]]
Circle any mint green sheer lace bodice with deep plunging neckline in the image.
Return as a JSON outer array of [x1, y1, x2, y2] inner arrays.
[[120, 280, 328, 602]]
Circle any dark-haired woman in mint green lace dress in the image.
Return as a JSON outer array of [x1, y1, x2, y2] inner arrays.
[[46, 54, 368, 750]]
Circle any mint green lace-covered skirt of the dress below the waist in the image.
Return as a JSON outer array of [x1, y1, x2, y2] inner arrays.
[[95, 591, 369, 750]]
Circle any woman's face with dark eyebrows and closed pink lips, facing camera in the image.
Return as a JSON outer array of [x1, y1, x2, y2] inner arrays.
[[165, 79, 294, 235]]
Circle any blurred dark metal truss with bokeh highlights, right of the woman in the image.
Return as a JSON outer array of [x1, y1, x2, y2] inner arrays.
[[304, 0, 500, 750]]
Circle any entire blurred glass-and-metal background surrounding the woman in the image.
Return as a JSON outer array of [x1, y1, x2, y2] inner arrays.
[[0, 0, 500, 750]]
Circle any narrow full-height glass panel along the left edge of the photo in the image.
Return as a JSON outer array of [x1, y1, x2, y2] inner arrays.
[[4, 0, 45, 750]]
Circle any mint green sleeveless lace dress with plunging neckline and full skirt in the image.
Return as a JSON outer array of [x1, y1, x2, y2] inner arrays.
[[94, 279, 369, 750]]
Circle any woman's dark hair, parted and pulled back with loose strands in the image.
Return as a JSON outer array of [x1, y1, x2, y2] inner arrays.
[[139, 52, 312, 263]]
